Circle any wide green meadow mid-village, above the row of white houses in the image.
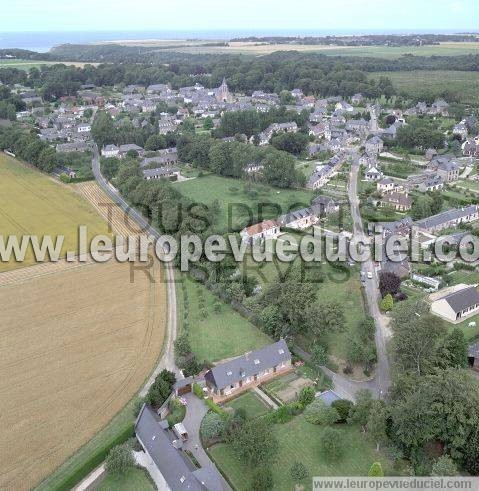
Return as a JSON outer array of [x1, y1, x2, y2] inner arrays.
[[175, 175, 313, 231]]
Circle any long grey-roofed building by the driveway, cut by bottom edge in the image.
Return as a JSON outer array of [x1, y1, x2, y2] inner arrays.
[[135, 404, 227, 491]]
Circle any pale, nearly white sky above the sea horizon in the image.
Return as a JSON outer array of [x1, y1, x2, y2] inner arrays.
[[0, 0, 479, 36]]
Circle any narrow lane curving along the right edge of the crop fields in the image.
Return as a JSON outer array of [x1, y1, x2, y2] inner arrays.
[[92, 145, 180, 390]]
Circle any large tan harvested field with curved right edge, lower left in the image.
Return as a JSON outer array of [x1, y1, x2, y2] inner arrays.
[[0, 261, 166, 490]]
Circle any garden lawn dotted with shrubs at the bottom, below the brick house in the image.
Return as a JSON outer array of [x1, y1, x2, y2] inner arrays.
[[210, 416, 393, 491]]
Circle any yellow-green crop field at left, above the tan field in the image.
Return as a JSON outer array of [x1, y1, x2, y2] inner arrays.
[[0, 153, 108, 271]]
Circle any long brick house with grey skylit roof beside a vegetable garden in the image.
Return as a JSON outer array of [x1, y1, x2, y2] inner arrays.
[[205, 339, 291, 401]]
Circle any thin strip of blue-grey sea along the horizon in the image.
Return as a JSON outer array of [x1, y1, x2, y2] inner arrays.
[[0, 29, 468, 53]]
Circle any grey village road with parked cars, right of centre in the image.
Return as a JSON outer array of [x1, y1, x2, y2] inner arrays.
[[348, 160, 391, 398]]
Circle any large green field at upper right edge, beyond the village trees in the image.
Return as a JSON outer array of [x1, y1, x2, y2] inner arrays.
[[370, 70, 479, 104]]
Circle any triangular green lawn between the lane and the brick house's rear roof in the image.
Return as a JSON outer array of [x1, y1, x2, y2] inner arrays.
[[179, 277, 271, 361]]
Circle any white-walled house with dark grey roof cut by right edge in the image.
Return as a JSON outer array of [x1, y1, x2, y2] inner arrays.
[[431, 286, 479, 323]]
